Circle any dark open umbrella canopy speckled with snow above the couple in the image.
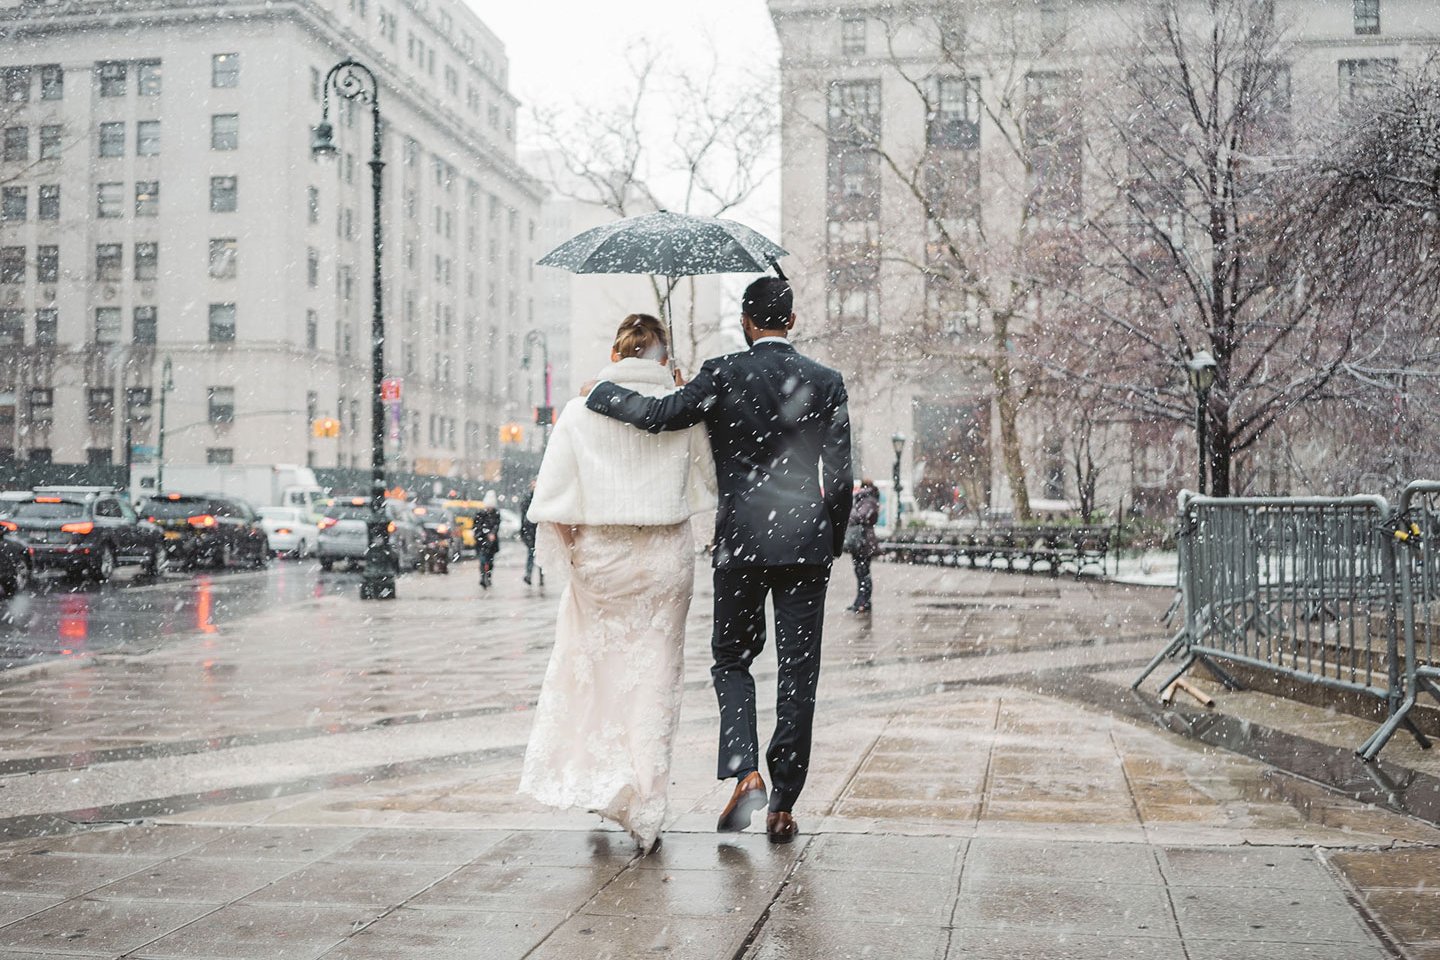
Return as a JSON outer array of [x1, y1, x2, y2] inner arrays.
[[536, 210, 785, 278]]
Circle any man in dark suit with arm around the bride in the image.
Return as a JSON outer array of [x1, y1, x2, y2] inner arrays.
[[586, 276, 852, 843]]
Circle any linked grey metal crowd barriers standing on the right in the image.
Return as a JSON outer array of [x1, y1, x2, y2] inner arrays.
[[1132, 482, 1440, 760]]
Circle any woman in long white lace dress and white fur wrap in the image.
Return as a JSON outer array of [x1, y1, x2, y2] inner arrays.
[[520, 314, 716, 852]]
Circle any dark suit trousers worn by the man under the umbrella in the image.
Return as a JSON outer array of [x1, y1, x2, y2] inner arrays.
[[710, 564, 829, 810]]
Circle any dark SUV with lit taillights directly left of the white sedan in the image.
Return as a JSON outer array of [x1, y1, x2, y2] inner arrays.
[[140, 494, 269, 567]]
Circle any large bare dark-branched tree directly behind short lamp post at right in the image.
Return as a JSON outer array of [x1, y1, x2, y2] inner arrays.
[[1036, 0, 1428, 495]]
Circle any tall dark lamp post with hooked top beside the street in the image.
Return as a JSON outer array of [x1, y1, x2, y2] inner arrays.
[[310, 59, 400, 600]]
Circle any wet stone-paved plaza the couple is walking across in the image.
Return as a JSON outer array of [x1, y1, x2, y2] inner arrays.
[[0, 554, 1440, 960]]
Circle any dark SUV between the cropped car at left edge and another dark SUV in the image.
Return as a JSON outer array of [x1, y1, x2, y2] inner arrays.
[[4, 488, 166, 580]]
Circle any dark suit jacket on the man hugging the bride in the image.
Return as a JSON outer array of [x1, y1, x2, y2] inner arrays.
[[586, 337, 854, 567]]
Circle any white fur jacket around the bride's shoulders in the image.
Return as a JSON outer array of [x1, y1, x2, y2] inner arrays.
[[530, 357, 716, 527]]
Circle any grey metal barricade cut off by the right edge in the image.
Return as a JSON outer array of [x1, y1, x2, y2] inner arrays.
[[1358, 481, 1440, 760]]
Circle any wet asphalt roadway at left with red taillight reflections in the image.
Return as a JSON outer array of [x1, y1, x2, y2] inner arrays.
[[0, 563, 359, 671]]
